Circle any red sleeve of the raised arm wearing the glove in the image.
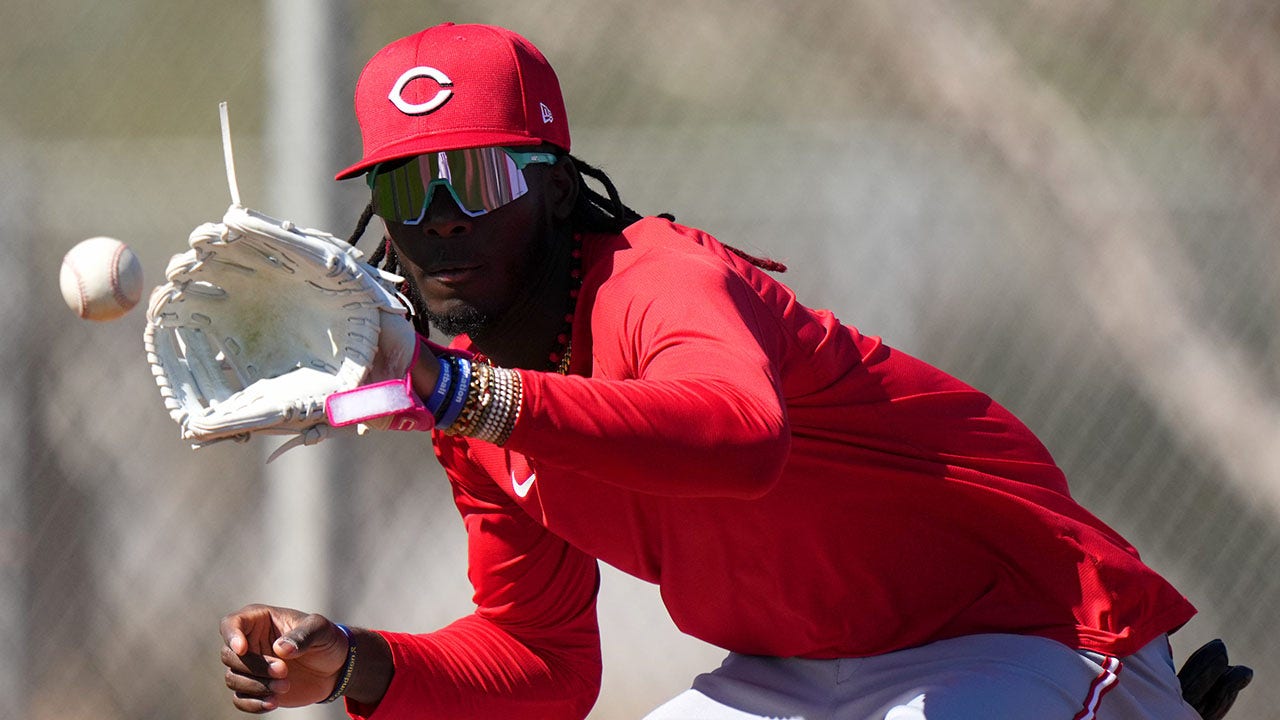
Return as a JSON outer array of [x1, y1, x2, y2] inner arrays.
[[507, 243, 790, 498]]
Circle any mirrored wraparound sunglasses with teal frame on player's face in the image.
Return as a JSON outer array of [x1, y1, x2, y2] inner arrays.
[[367, 147, 557, 225]]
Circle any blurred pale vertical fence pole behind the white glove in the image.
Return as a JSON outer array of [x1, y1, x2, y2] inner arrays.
[[262, 0, 349, 719]]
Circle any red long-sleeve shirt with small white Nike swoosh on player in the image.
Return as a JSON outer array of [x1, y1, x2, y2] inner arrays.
[[353, 218, 1194, 719]]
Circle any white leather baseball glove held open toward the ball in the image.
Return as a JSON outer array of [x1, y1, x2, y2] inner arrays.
[[143, 205, 417, 454]]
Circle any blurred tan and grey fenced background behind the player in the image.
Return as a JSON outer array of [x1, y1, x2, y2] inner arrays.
[[0, 0, 1280, 720]]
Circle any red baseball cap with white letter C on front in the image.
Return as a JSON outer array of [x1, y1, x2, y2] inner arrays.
[[337, 23, 570, 179]]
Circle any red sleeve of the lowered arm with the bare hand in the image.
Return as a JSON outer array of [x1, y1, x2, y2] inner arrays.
[[347, 448, 600, 720]]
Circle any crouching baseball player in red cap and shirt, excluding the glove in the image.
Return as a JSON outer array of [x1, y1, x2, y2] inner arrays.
[[221, 24, 1240, 720]]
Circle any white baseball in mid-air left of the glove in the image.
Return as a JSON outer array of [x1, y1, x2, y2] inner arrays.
[[58, 237, 142, 323]]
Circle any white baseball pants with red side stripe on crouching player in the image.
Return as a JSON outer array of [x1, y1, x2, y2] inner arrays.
[[645, 634, 1199, 720]]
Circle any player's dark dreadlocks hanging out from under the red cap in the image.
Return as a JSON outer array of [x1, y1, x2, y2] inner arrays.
[[347, 155, 787, 334]]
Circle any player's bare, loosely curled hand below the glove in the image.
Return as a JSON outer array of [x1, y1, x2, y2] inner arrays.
[[221, 605, 347, 714]]
